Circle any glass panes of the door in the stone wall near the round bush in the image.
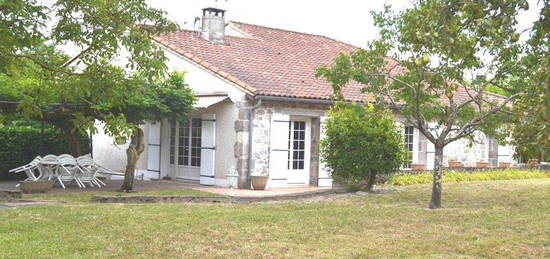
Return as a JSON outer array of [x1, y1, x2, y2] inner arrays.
[[287, 121, 306, 170]]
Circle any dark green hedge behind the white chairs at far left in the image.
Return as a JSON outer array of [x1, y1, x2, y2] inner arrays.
[[0, 126, 90, 180]]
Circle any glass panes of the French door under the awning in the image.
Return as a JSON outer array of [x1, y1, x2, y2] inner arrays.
[[170, 119, 202, 167]]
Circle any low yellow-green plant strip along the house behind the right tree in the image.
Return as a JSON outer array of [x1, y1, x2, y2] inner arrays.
[[386, 169, 550, 185]]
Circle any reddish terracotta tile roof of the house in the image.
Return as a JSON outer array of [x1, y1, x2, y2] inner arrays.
[[155, 22, 506, 102]]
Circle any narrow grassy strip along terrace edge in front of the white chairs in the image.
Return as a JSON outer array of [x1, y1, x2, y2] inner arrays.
[[23, 189, 219, 202]]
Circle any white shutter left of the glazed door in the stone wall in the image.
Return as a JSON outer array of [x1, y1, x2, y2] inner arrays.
[[269, 113, 290, 187]]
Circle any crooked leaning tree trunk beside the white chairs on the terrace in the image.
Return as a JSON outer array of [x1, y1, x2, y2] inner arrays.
[[120, 128, 145, 192]]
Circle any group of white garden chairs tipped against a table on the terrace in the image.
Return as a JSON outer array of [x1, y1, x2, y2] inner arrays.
[[10, 154, 124, 189]]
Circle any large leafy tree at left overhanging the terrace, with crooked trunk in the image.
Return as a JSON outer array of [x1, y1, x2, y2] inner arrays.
[[0, 0, 198, 191]]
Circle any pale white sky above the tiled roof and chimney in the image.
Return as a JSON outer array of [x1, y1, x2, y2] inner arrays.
[[147, 0, 539, 47]]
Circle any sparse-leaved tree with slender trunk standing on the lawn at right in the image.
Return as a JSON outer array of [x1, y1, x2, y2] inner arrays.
[[317, 0, 529, 209]]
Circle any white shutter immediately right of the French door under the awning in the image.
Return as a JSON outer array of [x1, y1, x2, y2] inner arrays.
[[200, 114, 216, 185]]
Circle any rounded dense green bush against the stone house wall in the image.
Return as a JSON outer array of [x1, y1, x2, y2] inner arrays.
[[321, 103, 406, 191]]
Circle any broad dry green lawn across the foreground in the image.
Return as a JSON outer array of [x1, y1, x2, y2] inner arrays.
[[0, 179, 550, 258]]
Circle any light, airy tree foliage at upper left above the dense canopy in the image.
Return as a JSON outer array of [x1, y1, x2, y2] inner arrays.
[[0, 0, 177, 78]]
